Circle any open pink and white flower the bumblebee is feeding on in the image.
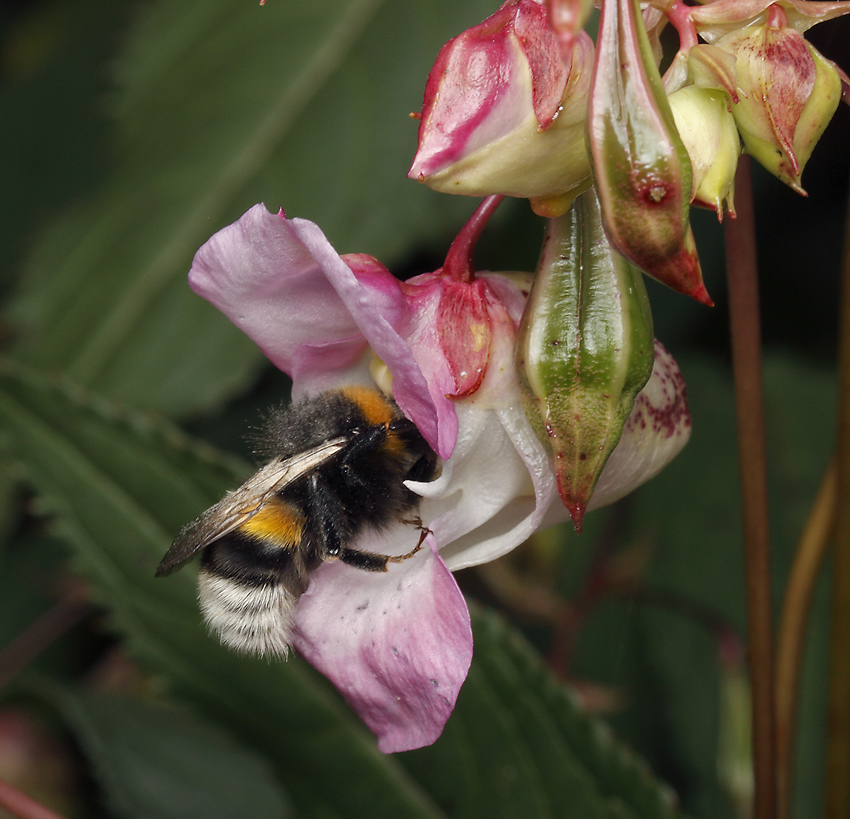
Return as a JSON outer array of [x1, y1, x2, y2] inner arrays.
[[189, 203, 690, 752]]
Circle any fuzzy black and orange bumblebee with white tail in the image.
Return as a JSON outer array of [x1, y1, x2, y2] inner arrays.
[[156, 387, 437, 656]]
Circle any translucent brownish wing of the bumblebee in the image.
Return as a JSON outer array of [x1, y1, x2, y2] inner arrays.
[[156, 438, 348, 577]]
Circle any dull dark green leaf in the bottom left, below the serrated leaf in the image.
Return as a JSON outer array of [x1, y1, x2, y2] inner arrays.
[[45, 686, 289, 819]]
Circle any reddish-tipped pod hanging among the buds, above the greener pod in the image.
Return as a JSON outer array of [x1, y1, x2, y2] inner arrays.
[[587, 0, 712, 305]]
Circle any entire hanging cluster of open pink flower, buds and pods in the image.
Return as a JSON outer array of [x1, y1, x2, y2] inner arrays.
[[176, 0, 850, 752]]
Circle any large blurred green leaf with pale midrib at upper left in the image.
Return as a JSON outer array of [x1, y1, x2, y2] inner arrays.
[[6, 0, 489, 413]]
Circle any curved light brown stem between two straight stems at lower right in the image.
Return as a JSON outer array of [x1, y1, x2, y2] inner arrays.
[[776, 460, 838, 819]]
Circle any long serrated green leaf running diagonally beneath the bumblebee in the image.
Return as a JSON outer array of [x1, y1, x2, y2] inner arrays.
[[0, 362, 680, 819]]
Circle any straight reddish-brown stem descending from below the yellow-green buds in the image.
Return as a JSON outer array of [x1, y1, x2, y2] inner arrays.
[[724, 157, 777, 819]]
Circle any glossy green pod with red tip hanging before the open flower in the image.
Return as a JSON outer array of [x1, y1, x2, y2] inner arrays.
[[516, 189, 653, 531]]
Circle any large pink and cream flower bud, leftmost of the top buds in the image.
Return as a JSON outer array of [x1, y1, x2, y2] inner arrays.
[[408, 0, 593, 209]]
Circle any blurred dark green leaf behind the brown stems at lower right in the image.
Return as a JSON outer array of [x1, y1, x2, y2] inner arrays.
[[564, 350, 836, 819]]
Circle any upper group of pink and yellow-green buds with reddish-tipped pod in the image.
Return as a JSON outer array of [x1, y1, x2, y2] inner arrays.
[[409, 0, 850, 294]]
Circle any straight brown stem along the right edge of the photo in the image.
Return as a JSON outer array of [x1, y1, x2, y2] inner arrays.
[[824, 160, 850, 819]]
